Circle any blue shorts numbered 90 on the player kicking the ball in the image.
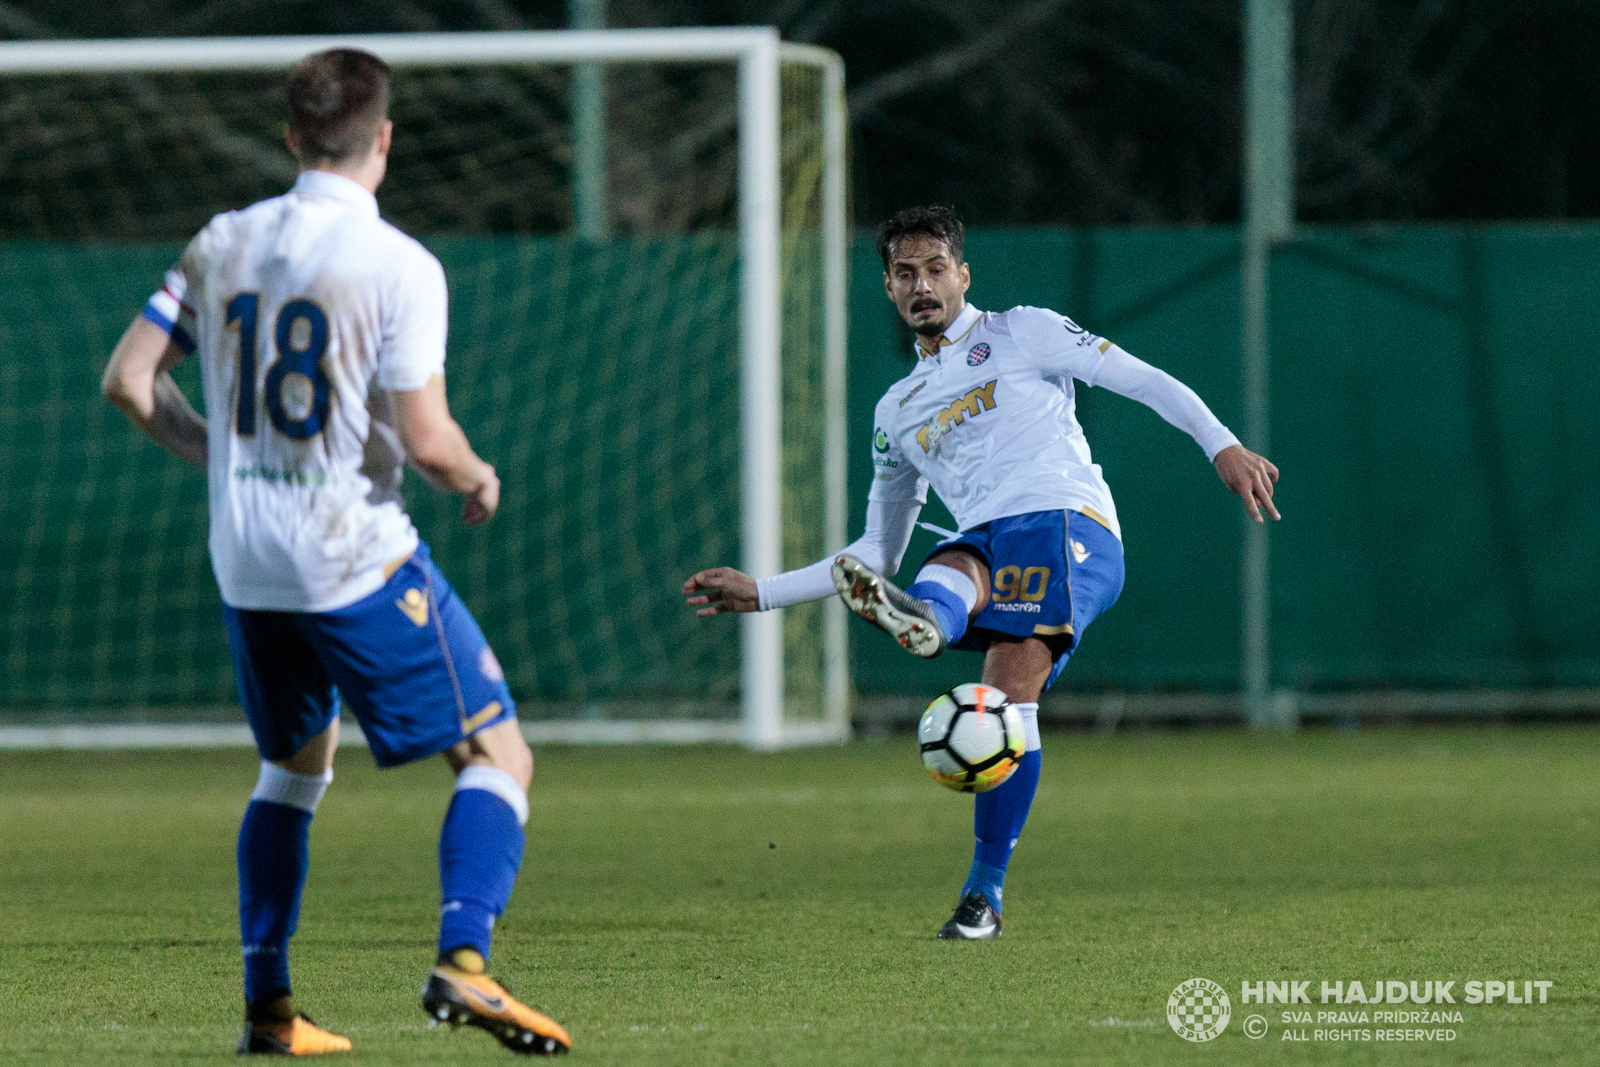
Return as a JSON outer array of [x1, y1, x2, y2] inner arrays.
[[928, 510, 1123, 689]]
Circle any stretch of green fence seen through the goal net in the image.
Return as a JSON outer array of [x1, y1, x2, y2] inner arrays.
[[0, 235, 745, 717]]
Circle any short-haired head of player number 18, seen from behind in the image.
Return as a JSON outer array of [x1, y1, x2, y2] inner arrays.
[[290, 48, 389, 163]]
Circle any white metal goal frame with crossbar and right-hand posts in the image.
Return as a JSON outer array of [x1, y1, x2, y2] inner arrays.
[[0, 27, 851, 749]]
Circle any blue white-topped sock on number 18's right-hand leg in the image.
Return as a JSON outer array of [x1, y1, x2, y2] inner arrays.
[[438, 765, 528, 961]]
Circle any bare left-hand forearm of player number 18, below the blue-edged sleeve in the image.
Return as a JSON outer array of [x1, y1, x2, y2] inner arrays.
[[101, 315, 206, 467]]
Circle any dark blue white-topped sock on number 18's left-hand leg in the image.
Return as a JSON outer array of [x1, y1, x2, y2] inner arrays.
[[238, 760, 333, 1005]]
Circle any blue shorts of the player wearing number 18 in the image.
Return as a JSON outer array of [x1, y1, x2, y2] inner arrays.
[[222, 544, 517, 766]]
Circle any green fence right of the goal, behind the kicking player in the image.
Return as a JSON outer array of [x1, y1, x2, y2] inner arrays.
[[851, 226, 1600, 693]]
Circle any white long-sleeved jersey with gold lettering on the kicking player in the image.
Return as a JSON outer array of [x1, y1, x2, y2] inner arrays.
[[869, 304, 1237, 537]]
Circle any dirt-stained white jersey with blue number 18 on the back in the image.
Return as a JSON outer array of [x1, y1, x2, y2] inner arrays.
[[146, 171, 446, 611]]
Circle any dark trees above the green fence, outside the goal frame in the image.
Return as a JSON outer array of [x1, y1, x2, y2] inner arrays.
[[0, 0, 1600, 226]]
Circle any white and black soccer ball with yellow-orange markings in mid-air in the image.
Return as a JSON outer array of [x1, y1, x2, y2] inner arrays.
[[917, 681, 1027, 793]]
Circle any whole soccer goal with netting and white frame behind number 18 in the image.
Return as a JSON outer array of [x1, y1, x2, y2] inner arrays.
[[0, 29, 848, 747]]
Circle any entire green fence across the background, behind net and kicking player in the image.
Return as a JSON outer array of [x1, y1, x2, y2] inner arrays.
[[0, 226, 1600, 710]]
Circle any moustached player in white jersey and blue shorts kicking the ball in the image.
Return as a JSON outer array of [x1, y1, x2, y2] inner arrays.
[[683, 208, 1278, 939]]
